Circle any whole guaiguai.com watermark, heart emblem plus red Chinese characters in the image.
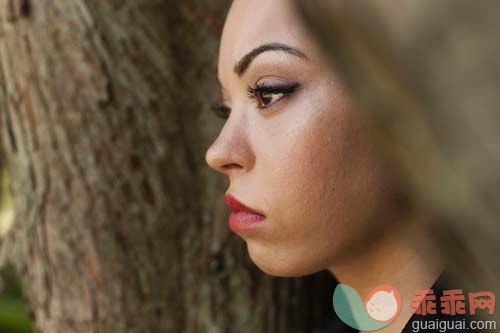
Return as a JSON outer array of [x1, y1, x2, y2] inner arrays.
[[333, 284, 496, 332]]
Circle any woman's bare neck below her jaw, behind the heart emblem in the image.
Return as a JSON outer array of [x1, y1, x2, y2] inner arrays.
[[328, 214, 444, 333]]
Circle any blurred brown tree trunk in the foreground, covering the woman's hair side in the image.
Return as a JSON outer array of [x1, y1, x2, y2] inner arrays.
[[296, 0, 500, 316]]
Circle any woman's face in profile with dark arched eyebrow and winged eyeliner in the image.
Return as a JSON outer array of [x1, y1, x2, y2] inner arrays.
[[206, 0, 402, 276]]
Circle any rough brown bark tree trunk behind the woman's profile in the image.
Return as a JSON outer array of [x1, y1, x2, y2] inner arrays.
[[0, 0, 334, 333]]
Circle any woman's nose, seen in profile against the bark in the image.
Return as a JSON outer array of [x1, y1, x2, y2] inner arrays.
[[205, 123, 255, 175]]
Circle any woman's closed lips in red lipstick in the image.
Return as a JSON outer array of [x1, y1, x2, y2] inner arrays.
[[224, 194, 266, 233]]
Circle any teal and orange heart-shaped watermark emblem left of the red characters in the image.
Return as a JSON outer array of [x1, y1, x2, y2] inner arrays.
[[333, 284, 401, 331]]
